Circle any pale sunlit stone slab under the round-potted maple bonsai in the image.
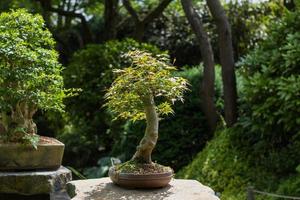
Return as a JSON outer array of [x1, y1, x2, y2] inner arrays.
[[67, 178, 219, 200]]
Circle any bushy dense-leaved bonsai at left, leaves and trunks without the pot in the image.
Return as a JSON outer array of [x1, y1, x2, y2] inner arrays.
[[0, 9, 72, 146]]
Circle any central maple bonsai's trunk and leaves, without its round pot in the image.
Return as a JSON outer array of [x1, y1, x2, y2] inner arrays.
[[105, 51, 187, 167]]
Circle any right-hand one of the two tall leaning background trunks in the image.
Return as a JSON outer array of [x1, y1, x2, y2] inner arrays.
[[206, 0, 237, 127]]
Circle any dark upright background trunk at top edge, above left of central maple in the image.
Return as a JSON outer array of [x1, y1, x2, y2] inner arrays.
[[104, 0, 119, 40]]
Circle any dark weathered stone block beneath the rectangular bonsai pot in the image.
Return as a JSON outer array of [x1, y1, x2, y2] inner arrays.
[[0, 167, 72, 195]]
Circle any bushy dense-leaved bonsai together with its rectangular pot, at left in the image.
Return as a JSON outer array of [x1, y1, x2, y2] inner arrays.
[[0, 9, 72, 170]]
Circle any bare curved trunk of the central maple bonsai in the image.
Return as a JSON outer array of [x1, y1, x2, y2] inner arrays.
[[131, 95, 158, 164]]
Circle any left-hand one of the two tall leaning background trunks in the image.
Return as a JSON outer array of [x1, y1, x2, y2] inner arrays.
[[181, 0, 218, 132]]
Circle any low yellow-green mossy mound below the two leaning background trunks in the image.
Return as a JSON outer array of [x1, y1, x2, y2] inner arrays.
[[176, 128, 278, 200]]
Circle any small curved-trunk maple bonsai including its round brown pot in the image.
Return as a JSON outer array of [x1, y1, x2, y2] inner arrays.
[[105, 51, 187, 188]]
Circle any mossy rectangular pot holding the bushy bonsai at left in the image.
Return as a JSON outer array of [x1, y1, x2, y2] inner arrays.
[[0, 138, 65, 171]]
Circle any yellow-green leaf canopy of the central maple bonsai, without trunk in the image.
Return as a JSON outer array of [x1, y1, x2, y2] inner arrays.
[[105, 51, 187, 121]]
